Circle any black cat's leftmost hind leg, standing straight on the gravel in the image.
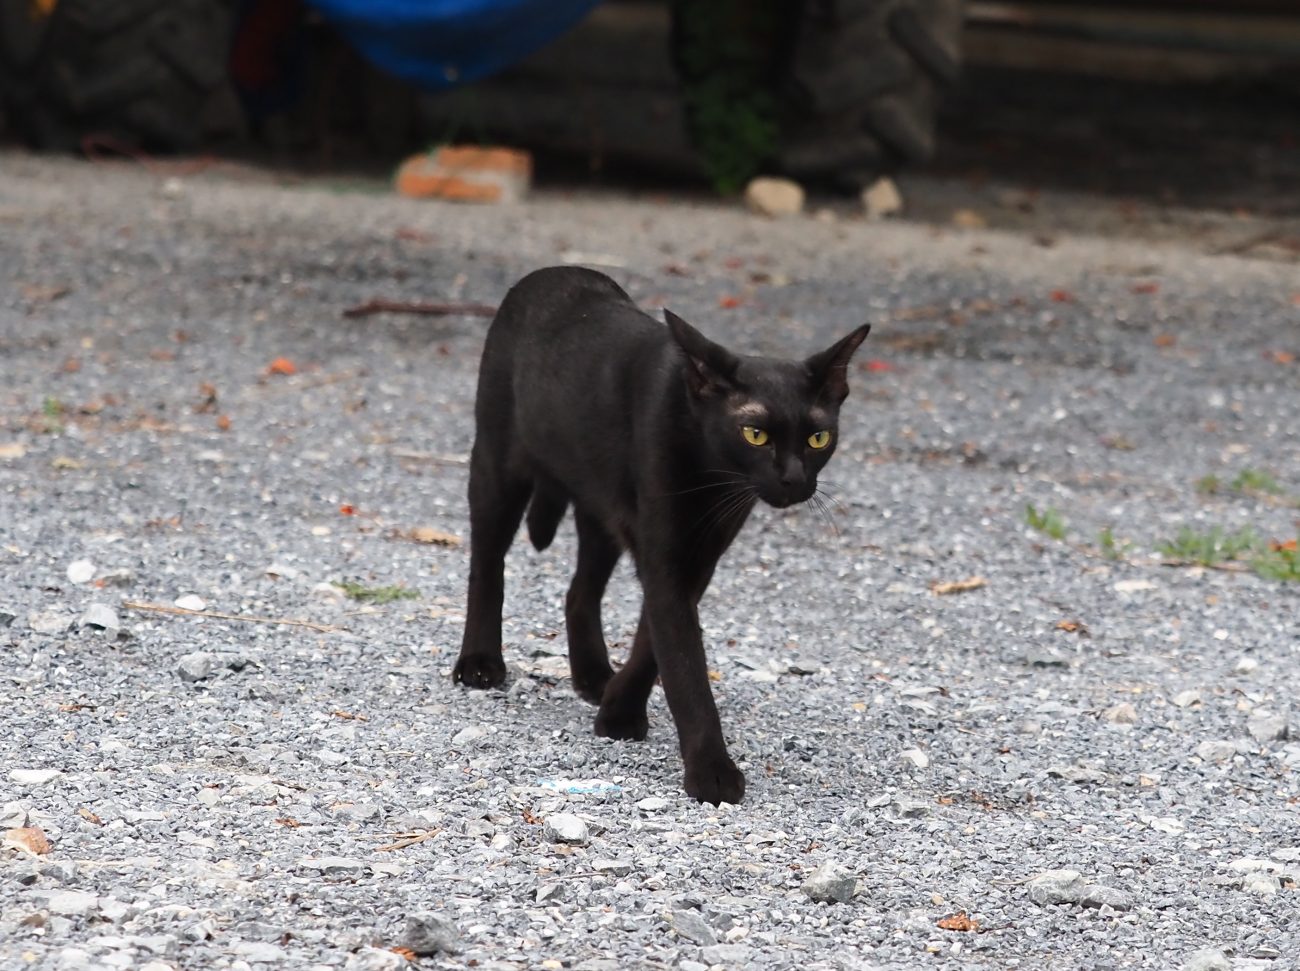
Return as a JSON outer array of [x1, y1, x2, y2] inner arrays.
[[451, 435, 533, 688]]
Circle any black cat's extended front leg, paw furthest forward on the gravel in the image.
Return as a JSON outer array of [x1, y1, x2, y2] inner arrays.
[[641, 571, 745, 805]]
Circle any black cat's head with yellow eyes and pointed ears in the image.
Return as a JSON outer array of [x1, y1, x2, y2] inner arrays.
[[663, 309, 871, 508]]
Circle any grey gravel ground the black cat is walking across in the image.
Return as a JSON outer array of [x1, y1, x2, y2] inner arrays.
[[0, 155, 1300, 971]]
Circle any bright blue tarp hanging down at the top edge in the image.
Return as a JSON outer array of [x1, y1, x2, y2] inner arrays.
[[308, 0, 598, 88]]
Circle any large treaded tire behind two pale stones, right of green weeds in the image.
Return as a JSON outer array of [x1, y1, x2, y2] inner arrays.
[[777, 0, 963, 187]]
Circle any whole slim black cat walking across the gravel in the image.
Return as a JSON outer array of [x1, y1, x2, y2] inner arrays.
[[454, 266, 868, 803]]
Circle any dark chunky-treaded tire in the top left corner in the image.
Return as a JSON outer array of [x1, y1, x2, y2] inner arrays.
[[0, 0, 234, 152]]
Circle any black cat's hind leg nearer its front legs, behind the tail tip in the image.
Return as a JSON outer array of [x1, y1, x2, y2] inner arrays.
[[564, 512, 621, 705]]
